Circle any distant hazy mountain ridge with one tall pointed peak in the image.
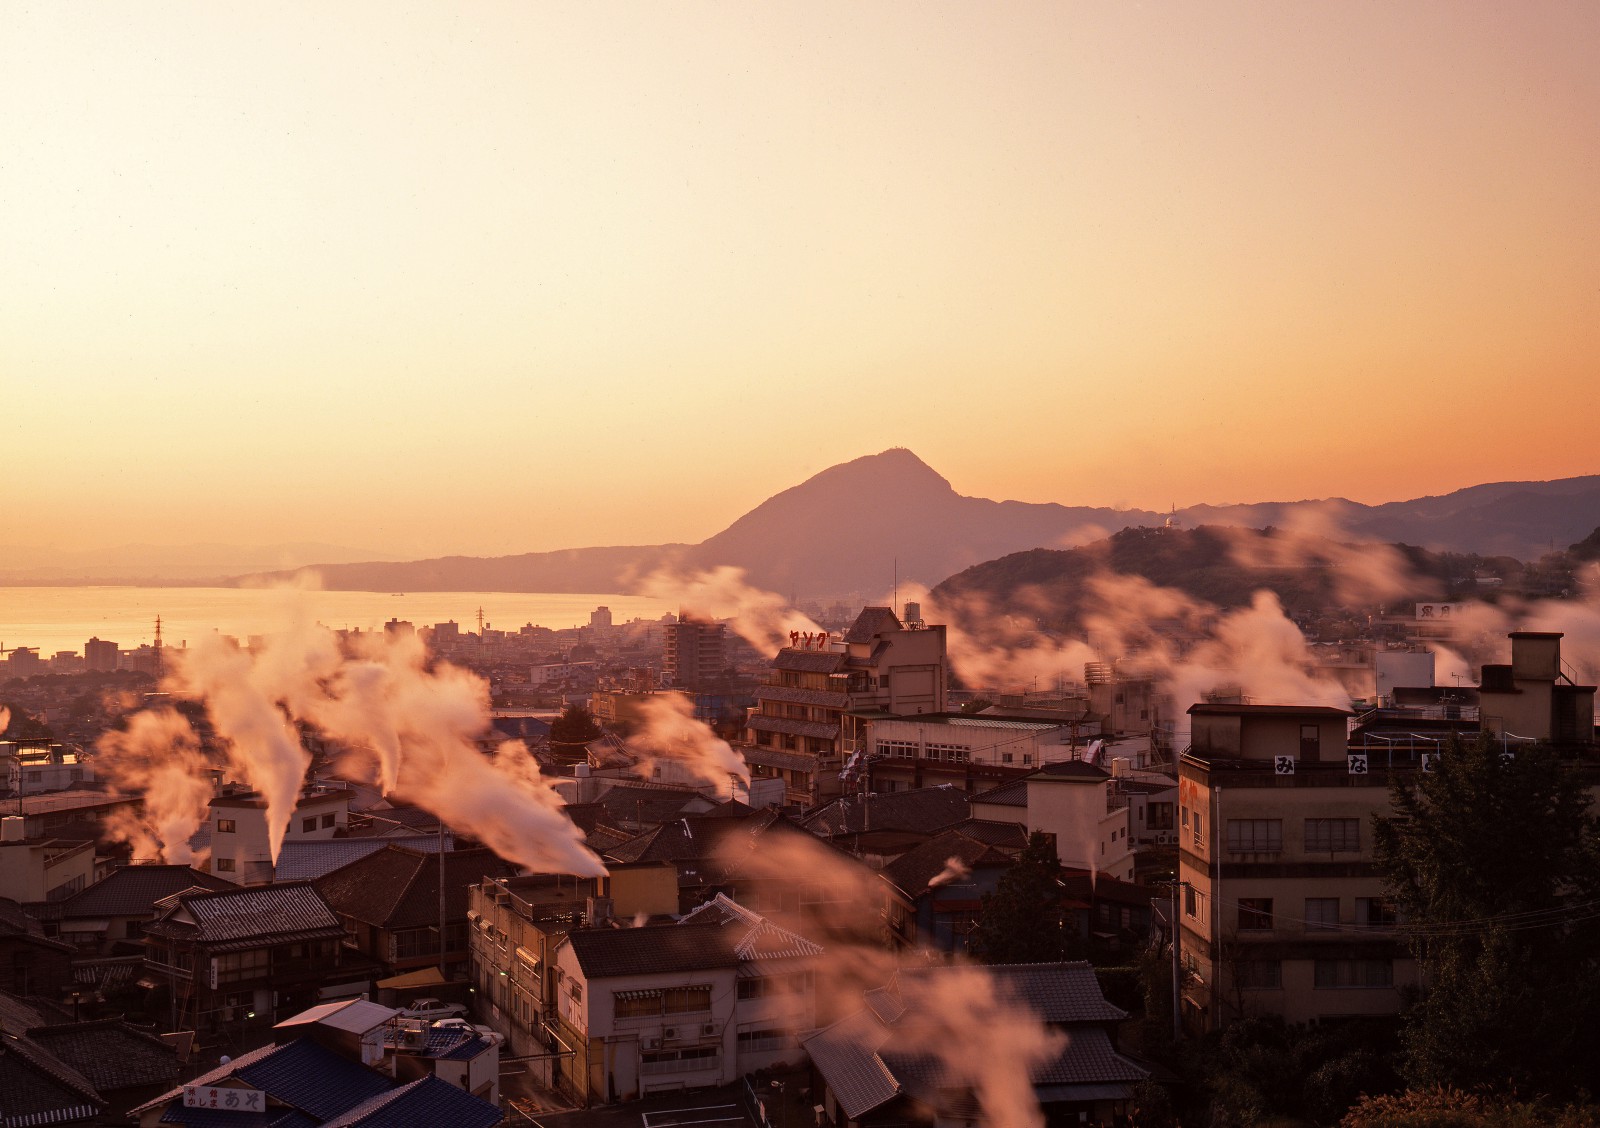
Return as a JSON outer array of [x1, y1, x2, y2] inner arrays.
[[233, 448, 1600, 598]]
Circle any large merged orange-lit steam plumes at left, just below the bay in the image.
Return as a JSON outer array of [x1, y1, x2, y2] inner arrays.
[[96, 600, 605, 877]]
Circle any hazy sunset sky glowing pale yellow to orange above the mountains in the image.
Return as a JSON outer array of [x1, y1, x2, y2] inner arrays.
[[0, 0, 1600, 554]]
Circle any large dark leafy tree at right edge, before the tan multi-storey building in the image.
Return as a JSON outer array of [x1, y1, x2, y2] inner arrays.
[[1374, 736, 1600, 1093]]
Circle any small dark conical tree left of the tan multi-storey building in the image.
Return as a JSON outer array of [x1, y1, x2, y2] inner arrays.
[[971, 830, 1078, 963]]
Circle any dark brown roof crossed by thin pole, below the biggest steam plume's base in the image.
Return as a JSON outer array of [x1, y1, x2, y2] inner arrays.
[[317, 843, 517, 928]]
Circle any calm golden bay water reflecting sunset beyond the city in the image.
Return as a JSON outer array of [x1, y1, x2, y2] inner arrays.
[[0, 587, 677, 658]]
